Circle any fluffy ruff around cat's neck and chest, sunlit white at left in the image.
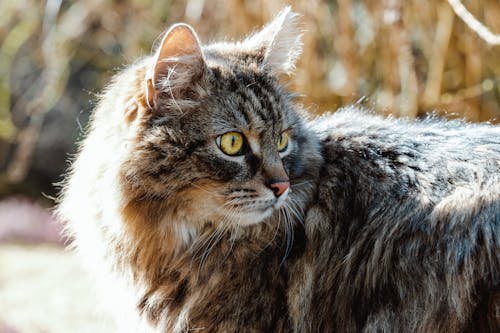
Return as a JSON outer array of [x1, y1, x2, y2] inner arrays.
[[59, 14, 320, 326]]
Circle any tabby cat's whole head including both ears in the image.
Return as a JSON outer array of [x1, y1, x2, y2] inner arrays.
[[114, 8, 318, 240]]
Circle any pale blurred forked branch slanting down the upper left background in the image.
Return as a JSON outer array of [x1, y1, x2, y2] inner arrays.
[[6, 0, 102, 183]]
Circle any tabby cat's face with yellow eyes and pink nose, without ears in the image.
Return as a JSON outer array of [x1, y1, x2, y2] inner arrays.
[[144, 66, 305, 225]]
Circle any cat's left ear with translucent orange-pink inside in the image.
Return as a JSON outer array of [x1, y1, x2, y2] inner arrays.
[[146, 23, 205, 108]]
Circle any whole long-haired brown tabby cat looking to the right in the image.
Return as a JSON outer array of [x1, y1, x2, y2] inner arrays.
[[58, 7, 500, 332]]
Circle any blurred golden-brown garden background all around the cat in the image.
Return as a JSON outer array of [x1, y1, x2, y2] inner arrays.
[[0, 0, 500, 333]]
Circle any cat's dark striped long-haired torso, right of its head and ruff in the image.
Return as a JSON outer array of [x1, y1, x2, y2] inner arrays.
[[290, 107, 500, 332]]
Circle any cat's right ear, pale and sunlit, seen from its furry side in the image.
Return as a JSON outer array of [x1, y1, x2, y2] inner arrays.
[[243, 6, 302, 74]]
